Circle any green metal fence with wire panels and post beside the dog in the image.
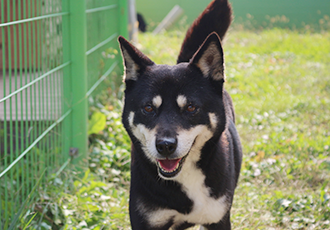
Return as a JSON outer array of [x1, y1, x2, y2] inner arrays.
[[0, 0, 127, 229]]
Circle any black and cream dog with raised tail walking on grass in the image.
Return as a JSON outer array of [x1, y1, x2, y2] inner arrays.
[[118, 0, 242, 230]]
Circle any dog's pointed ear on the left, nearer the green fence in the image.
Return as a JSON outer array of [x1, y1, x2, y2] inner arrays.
[[118, 36, 155, 82]]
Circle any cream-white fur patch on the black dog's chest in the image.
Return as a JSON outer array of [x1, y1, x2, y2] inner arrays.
[[145, 162, 228, 227]]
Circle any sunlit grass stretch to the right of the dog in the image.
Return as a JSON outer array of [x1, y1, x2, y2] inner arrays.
[[225, 29, 330, 229]]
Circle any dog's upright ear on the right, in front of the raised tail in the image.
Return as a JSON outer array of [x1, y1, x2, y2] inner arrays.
[[190, 32, 225, 82]]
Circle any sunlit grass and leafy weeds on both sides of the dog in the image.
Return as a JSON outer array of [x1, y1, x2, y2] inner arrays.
[[22, 29, 330, 229]]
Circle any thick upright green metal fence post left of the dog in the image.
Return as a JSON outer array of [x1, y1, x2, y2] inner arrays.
[[69, 0, 88, 168]]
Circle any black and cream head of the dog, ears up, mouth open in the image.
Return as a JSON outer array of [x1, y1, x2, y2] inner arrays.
[[118, 33, 226, 179]]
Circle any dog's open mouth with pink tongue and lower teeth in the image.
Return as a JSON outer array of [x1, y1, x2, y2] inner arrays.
[[157, 155, 187, 178]]
